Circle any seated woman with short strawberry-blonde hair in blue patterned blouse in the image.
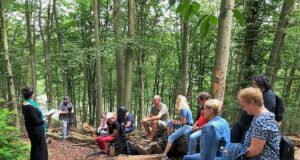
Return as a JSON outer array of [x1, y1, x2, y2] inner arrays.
[[228, 87, 281, 160]]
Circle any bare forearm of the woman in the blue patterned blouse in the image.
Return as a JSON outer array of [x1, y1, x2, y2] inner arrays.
[[247, 137, 266, 158]]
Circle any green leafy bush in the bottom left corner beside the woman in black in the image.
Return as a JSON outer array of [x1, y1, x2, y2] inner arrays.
[[0, 108, 30, 160]]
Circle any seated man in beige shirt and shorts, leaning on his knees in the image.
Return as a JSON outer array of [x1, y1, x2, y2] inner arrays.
[[141, 95, 169, 141]]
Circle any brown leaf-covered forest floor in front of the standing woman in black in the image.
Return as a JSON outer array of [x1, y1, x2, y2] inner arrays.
[[48, 138, 300, 160]]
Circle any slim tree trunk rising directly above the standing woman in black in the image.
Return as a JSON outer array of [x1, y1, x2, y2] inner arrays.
[[25, 0, 37, 98]]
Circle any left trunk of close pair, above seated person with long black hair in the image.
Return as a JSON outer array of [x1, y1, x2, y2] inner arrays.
[[114, 0, 125, 107]]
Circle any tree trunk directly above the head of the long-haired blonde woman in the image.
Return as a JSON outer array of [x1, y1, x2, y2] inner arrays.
[[180, 21, 189, 96]]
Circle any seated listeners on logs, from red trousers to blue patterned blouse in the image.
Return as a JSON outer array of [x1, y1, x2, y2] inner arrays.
[[96, 75, 281, 160]]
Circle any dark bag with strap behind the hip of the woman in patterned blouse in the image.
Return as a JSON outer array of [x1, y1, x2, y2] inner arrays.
[[267, 136, 295, 160]]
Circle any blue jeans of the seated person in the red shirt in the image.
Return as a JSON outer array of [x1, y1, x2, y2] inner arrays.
[[184, 128, 202, 155]]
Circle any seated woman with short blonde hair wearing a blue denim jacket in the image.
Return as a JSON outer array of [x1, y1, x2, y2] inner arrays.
[[183, 99, 230, 160]]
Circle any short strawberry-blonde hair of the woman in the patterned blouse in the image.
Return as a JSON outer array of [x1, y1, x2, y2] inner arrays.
[[237, 87, 264, 106]]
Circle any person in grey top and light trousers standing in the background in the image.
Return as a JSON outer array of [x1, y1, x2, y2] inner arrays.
[[58, 96, 73, 142]]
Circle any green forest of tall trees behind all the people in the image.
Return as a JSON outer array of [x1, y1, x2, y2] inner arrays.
[[0, 0, 300, 159]]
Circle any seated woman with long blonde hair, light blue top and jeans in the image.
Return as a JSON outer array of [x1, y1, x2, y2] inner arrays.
[[162, 95, 193, 159]]
